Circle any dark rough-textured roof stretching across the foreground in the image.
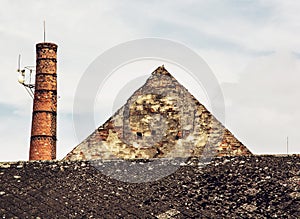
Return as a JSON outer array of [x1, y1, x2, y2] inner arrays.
[[0, 156, 300, 218]]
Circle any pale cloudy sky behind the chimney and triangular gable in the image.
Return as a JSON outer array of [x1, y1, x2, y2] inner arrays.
[[0, 0, 300, 161]]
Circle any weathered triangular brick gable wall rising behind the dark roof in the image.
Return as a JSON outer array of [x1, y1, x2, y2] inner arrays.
[[64, 66, 251, 160]]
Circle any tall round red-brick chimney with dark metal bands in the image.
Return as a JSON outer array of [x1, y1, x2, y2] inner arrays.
[[29, 42, 57, 160]]
